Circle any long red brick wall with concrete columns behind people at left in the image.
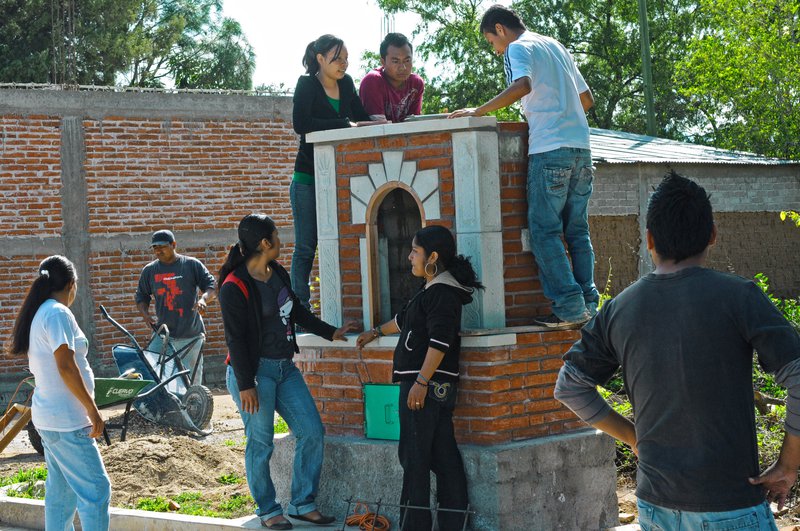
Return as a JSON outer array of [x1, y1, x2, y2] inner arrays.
[[0, 90, 306, 403]]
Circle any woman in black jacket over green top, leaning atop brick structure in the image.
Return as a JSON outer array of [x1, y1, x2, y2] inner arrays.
[[289, 35, 387, 308]]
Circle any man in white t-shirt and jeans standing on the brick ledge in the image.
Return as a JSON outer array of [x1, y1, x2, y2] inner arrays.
[[450, 5, 600, 329]]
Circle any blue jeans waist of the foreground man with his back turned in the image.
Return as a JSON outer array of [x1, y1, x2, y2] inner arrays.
[[637, 500, 778, 531]]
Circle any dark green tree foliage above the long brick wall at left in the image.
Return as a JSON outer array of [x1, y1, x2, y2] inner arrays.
[[0, 0, 255, 89]]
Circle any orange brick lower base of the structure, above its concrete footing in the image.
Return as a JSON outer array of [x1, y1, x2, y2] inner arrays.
[[295, 331, 585, 445]]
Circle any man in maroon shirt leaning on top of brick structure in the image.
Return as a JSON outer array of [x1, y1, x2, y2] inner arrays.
[[358, 33, 425, 123]]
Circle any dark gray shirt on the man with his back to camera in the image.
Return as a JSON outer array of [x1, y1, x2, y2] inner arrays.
[[564, 267, 800, 512]]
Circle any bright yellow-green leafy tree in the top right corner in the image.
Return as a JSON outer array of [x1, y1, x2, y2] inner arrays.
[[676, 0, 800, 159]]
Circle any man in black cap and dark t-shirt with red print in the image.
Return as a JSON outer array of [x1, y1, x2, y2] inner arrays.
[[136, 230, 216, 385]]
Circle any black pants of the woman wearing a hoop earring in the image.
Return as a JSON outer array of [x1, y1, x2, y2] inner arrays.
[[397, 382, 467, 531]]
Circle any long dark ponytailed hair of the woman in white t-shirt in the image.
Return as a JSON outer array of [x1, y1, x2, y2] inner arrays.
[[8, 255, 78, 354]]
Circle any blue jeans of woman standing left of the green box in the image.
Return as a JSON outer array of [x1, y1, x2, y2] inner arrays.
[[226, 358, 325, 519]]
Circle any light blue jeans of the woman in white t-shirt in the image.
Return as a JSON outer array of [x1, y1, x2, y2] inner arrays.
[[38, 428, 111, 531]]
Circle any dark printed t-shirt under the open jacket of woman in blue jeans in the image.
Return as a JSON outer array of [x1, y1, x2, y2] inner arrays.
[[256, 274, 294, 359]]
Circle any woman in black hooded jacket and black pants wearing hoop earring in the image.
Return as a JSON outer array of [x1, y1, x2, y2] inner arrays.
[[356, 225, 483, 531]]
